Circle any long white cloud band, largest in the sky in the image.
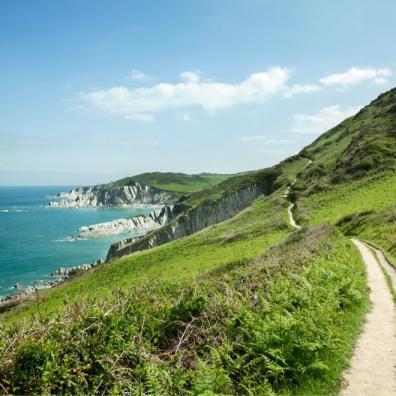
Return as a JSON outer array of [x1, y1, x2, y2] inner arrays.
[[77, 67, 290, 122]]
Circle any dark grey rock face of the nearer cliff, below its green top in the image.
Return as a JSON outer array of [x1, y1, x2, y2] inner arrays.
[[107, 186, 263, 260]]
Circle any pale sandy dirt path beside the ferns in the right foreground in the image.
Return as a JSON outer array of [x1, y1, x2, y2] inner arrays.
[[340, 239, 396, 396]]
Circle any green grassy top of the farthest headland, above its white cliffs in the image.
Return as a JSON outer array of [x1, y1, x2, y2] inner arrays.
[[109, 172, 235, 194]]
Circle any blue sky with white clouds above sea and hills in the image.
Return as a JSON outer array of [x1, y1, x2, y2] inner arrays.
[[0, 0, 396, 185]]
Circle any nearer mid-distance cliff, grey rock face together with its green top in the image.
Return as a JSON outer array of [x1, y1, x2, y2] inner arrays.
[[107, 156, 309, 260]]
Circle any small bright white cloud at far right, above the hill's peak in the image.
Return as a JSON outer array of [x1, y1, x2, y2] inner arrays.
[[320, 67, 392, 87]]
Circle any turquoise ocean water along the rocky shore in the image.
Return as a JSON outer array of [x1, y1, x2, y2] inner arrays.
[[0, 186, 151, 298]]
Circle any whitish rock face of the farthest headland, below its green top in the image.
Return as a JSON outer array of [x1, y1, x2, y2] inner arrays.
[[48, 182, 177, 208]]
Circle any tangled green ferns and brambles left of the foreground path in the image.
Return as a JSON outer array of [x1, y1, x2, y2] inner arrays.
[[0, 227, 367, 395]]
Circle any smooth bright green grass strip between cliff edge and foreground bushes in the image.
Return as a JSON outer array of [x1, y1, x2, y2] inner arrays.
[[3, 192, 291, 320]]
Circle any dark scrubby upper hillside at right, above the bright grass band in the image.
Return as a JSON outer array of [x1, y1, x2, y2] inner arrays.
[[296, 88, 396, 192]]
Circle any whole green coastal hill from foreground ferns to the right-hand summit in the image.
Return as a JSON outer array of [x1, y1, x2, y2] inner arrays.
[[0, 89, 396, 395]]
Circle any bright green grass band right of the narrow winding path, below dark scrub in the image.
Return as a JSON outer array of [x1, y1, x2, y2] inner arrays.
[[297, 173, 396, 225]]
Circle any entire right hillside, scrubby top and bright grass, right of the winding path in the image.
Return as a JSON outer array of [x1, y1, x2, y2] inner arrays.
[[293, 89, 396, 276]]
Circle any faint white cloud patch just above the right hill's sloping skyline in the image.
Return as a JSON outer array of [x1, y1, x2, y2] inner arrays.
[[292, 105, 360, 135]]
